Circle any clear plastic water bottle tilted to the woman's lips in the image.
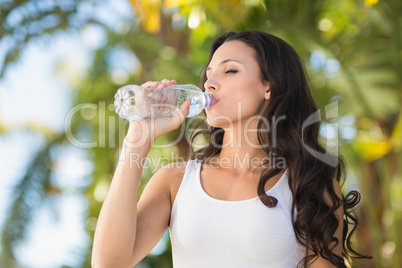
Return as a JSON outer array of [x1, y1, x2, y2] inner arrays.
[[114, 85, 215, 120]]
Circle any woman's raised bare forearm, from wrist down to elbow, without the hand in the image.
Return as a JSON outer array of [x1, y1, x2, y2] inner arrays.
[[92, 128, 151, 268]]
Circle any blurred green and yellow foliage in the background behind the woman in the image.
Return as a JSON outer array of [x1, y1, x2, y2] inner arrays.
[[0, 0, 402, 268]]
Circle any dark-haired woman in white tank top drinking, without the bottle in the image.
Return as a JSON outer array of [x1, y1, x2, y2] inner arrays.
[[92, 31, 368, 268]]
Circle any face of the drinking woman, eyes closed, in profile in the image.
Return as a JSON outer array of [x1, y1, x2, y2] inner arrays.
[[204, 40, 269, 128]]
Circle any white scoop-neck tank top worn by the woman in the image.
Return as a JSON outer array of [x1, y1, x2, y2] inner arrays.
[[169, 160, 306, 268]]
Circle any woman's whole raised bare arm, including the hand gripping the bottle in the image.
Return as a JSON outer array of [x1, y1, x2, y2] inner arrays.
[[92, 81, 189, 268]]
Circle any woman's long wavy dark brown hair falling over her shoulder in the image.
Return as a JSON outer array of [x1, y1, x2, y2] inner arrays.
[[192, 31, 367, 267]]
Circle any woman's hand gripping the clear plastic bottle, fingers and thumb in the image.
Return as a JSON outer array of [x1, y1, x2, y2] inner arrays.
[[126, 79, 191, 146]]
